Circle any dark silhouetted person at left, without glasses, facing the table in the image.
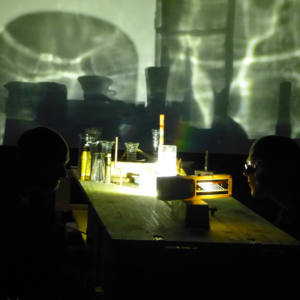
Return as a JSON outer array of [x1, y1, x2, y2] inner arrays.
[[0, 127, 69, 299]]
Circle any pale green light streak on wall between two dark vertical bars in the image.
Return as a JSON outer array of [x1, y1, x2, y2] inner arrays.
[[167, 1, 227, 129]]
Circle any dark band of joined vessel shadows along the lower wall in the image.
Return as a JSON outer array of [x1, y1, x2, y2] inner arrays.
[[4, 73, 250, 153]]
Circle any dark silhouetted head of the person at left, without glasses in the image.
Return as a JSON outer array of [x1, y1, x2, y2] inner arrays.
[[17, 127, 69, 192]]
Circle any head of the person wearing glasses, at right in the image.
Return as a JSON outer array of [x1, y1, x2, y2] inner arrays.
[[244, 135, 300, 209]]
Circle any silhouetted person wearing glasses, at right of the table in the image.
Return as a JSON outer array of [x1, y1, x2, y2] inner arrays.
[[244, 135, 300, 240]]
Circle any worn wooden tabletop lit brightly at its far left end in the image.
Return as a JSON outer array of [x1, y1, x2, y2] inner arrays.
[[79, 181, 300, 245]]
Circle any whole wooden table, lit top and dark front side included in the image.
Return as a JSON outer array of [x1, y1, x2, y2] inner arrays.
[[74, 177, 300, 299]]
